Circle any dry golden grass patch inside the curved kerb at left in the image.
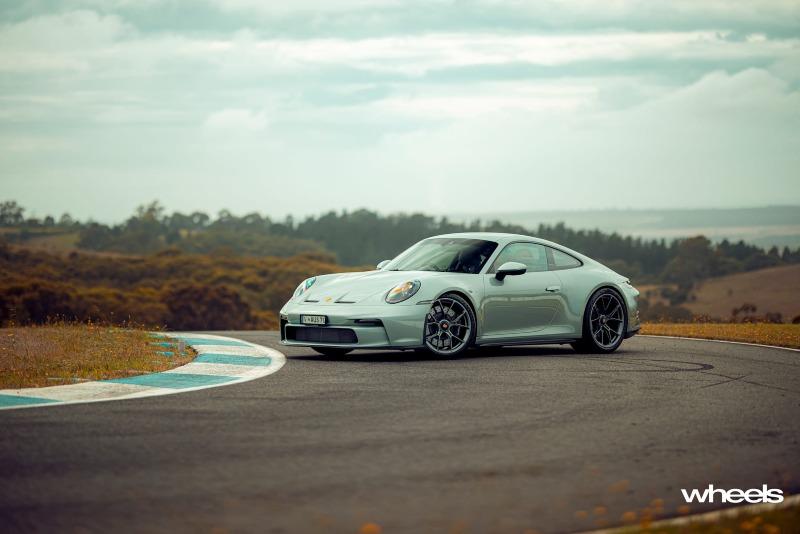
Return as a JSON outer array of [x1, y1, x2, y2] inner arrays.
[[0, 323, 194, 388]]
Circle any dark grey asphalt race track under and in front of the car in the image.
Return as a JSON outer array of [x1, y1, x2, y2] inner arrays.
[[0, 332, 800, 533]]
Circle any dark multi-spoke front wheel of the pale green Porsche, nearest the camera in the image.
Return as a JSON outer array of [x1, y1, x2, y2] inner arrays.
[[423, 294, 475, 358]]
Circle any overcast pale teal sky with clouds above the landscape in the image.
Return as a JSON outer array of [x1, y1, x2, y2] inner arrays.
[[0, 0, 800, 221]]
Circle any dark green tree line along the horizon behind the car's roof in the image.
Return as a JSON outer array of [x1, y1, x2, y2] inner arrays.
[[0, 201, 800, 288]]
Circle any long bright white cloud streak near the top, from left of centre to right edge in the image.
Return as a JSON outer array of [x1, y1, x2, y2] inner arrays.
[[206, 31, 800, 75]]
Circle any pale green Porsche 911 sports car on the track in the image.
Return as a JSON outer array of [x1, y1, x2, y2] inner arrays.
[[280, 232, 639, 356]]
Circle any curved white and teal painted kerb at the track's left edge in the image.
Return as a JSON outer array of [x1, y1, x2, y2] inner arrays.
[[0, 333, 286, 410]]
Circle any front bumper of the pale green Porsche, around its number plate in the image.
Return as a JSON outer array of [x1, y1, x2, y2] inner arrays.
[[280, 302, 430, 349]]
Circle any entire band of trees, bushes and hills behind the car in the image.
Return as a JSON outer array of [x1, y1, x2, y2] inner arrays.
[[0, 201, 800, 330]]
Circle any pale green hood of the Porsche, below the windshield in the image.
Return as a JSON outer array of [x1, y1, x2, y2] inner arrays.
[[298, 271, 438, 304]]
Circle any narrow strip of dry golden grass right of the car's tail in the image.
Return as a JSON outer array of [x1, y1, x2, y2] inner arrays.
[[641, 323, 800, 349]]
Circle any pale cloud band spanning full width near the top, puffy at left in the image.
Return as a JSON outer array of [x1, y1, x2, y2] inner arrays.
[[0, 11, 800, 76]]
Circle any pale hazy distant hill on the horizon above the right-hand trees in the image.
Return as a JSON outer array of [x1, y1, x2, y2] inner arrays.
[[451, 206, 800, 248]]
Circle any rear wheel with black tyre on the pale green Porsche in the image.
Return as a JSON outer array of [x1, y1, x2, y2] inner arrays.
[[571, 287, 628, 354]]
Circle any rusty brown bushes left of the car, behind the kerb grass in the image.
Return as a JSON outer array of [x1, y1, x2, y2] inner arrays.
[[0, 243, 346, 330]]
